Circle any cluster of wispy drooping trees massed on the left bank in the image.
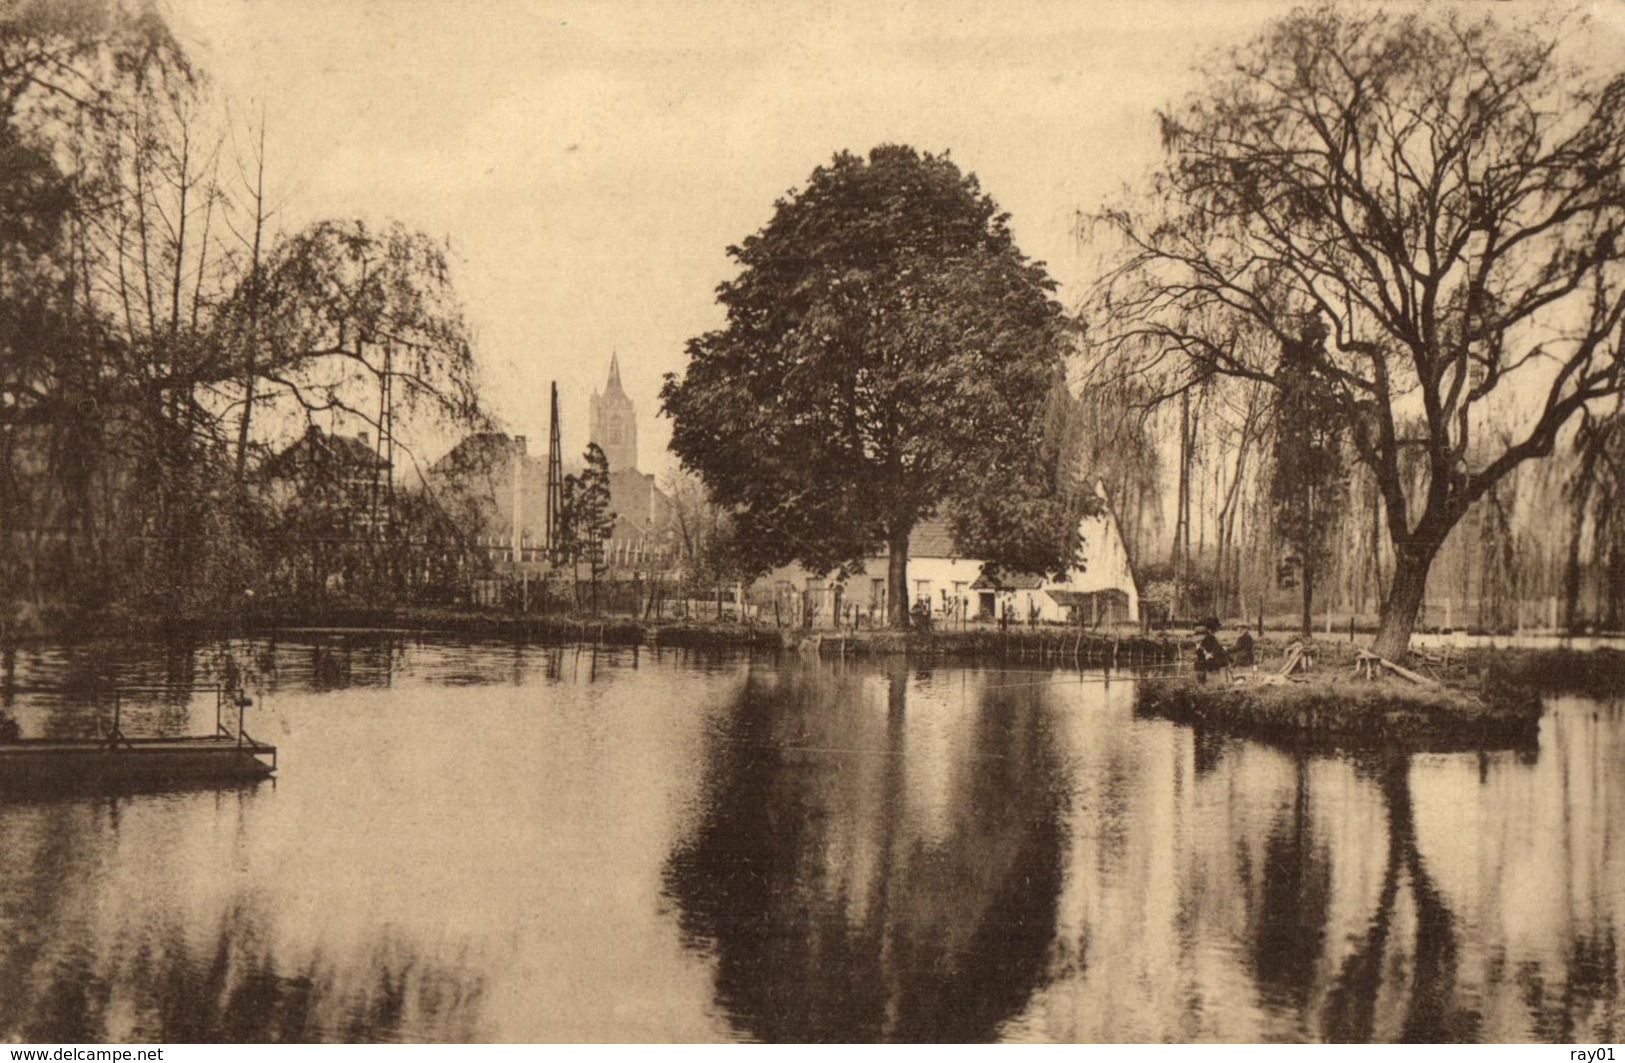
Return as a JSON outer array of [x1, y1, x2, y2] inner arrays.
[[0, 0, 481, 631]]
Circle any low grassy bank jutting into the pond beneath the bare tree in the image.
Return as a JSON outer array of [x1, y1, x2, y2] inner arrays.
[[1134, 673, 1542, 751]]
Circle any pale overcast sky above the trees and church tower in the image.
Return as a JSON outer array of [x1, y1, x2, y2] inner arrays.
[[155, 0, 1617, 471]]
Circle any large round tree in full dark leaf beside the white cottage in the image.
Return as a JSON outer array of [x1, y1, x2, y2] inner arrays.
[[661, 145, 1089, 627]]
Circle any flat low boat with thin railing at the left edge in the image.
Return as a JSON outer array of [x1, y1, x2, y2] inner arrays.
[[0, 689, 276, 790]]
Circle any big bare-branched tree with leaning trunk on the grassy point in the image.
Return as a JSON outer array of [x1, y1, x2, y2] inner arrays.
[[1095, 5, 1625, 657]]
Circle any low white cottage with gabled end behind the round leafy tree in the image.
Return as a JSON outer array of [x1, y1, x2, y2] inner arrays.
[[751, 494, 1139, 626]]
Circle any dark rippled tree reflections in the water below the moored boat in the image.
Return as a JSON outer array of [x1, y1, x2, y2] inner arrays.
[[0, 792, 483, 1042]]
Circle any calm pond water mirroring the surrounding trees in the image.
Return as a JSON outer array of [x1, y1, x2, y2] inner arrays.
[[0, 636, 1625, 1042]]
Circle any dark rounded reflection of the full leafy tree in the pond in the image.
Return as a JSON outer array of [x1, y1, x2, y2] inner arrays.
[[666, 670, 1063, 1042]]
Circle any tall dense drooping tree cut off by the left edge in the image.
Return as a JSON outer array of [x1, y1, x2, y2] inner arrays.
[[0, 0, 193, 611]]
